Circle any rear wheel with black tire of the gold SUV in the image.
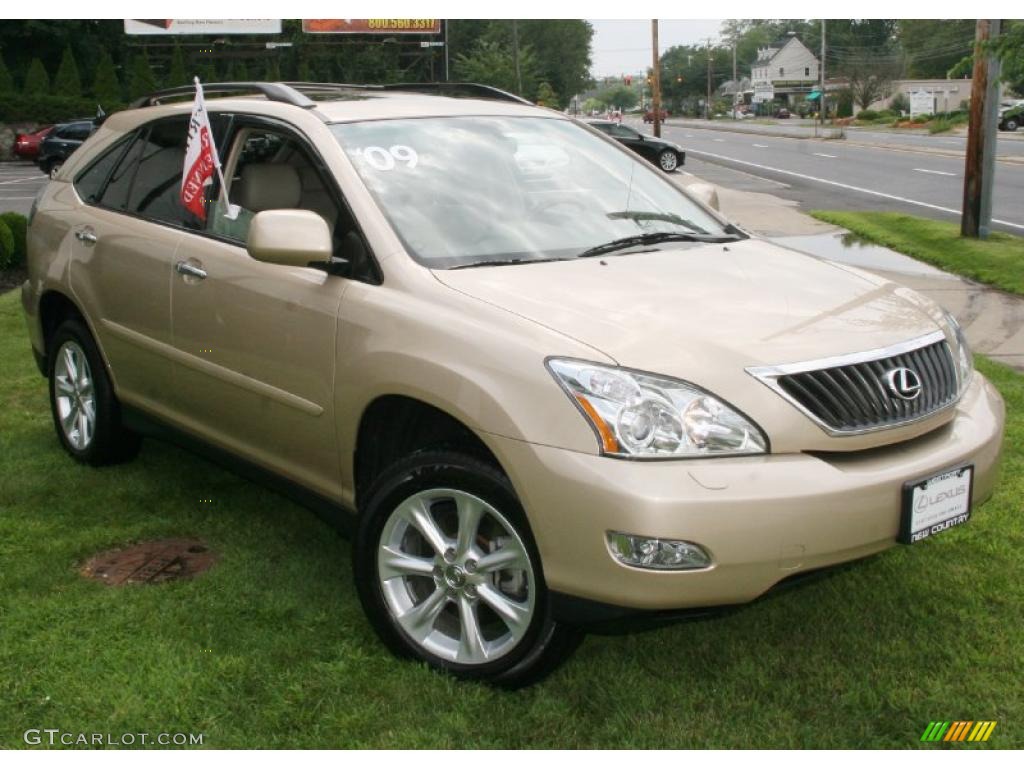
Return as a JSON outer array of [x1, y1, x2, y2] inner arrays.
[[47, 319, 141, 466]]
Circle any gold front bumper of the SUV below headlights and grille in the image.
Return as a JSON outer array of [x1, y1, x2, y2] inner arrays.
[[492, 374, 1004, 610]]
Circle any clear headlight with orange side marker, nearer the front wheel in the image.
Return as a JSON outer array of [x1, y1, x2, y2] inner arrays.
[[548, 357, 768, 459]]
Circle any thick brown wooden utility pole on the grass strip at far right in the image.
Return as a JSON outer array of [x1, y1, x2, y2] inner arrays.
[[961, 18, 999, 240]]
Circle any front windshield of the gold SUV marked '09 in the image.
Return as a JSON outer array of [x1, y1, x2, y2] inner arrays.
[[331, 117, 734, 269]]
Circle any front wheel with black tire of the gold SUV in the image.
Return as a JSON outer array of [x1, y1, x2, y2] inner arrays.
[[352, 451, 579, 688]]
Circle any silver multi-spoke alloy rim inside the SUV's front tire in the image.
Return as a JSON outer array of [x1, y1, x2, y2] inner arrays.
[[377, 488, 536, 665]]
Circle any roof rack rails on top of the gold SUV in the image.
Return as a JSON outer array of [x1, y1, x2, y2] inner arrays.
[[131, 81, 532, 110]]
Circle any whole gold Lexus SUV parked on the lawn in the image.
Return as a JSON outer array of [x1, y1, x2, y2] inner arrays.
[[23, 83, 1004, 686]]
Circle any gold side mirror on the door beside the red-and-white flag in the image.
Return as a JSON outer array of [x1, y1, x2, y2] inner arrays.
[[246, 209, 334, 266]]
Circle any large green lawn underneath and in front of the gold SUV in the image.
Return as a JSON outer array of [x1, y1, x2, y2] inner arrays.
[[0, 286, 1024, 750]]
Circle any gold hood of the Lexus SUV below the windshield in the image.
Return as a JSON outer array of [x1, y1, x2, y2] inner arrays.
[[434, 239, 940, 376]]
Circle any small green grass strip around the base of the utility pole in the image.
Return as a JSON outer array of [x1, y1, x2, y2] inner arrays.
[[811, 211, 1024, 294]]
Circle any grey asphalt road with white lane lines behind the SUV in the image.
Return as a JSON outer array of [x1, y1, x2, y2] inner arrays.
[[635, 123, 1024, 234]]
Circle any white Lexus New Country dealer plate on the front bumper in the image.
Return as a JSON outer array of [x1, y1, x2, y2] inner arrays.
[[899, 467, 974, 544]]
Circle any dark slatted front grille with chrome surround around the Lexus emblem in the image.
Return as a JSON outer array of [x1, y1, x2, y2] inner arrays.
[[751, 333, 959, 434]]
